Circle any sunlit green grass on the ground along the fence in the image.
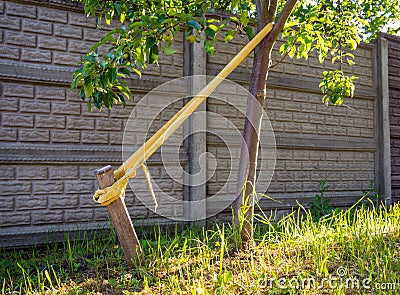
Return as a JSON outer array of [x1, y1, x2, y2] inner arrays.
[[0, 204, 400, 294]]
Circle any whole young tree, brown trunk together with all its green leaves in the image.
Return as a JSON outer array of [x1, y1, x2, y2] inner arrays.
[[71, 0, 400, 245]]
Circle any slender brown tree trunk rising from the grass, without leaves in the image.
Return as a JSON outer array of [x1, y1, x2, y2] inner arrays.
[[233, 0, 297, 246]]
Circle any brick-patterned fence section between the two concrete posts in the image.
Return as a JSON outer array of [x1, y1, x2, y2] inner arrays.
[[207, 32, 377, 217]]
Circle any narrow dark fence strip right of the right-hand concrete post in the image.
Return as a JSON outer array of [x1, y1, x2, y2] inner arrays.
[[385, 35, 400, 202]]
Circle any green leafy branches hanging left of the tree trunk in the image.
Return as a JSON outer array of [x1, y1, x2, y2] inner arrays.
[[71, 0, 255, 110]]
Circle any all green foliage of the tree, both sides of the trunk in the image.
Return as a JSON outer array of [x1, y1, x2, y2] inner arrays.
[[71, 0, 400, 110]]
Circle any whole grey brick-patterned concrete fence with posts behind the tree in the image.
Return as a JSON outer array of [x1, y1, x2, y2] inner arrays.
[[0, 0, 400, 246]]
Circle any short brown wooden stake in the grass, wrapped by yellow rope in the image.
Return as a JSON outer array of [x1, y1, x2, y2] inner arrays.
[[93, 165, 144, 267]]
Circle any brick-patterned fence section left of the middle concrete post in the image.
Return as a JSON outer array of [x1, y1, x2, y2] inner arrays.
[[0, 1, 185, 245]]
